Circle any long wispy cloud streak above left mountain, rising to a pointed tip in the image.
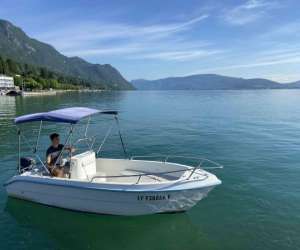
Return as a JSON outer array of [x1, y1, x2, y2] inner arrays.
[[36, 15, 208, 51]]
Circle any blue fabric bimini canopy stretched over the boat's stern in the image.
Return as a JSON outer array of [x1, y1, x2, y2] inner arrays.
[[14, 107, 118, 124]]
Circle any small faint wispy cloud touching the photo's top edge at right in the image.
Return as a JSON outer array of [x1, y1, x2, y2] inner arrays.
[[223, 0, 279, 25]]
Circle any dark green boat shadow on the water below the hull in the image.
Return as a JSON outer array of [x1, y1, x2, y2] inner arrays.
[[5, 198, 215, 250]]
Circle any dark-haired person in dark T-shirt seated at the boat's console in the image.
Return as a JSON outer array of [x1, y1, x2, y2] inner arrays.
[[46, 133, 73, 177]]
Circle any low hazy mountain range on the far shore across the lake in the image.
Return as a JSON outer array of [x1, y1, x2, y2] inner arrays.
[[131, 74, 300, 90]]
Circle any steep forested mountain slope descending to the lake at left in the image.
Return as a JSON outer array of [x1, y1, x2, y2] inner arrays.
[[0, 19, 133, 90]]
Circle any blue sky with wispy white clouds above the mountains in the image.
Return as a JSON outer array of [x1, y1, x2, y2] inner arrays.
[[0, 0, 300, 82]]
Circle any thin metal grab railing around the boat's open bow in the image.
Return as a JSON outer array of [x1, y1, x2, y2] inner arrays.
[[90, 155, 223, 184]]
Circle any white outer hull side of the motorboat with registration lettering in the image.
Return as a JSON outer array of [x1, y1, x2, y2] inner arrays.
[[6, 179, 218, 216]]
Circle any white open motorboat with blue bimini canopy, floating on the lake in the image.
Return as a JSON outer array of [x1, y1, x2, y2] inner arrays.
[[5, 107, 222, 215]]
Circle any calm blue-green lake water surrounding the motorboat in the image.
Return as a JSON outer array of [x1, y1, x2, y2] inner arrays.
[[0, 90, 300, 250]]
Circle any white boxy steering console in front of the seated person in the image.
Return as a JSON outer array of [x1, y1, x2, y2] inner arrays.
[[70, 151, 96, 180]]
